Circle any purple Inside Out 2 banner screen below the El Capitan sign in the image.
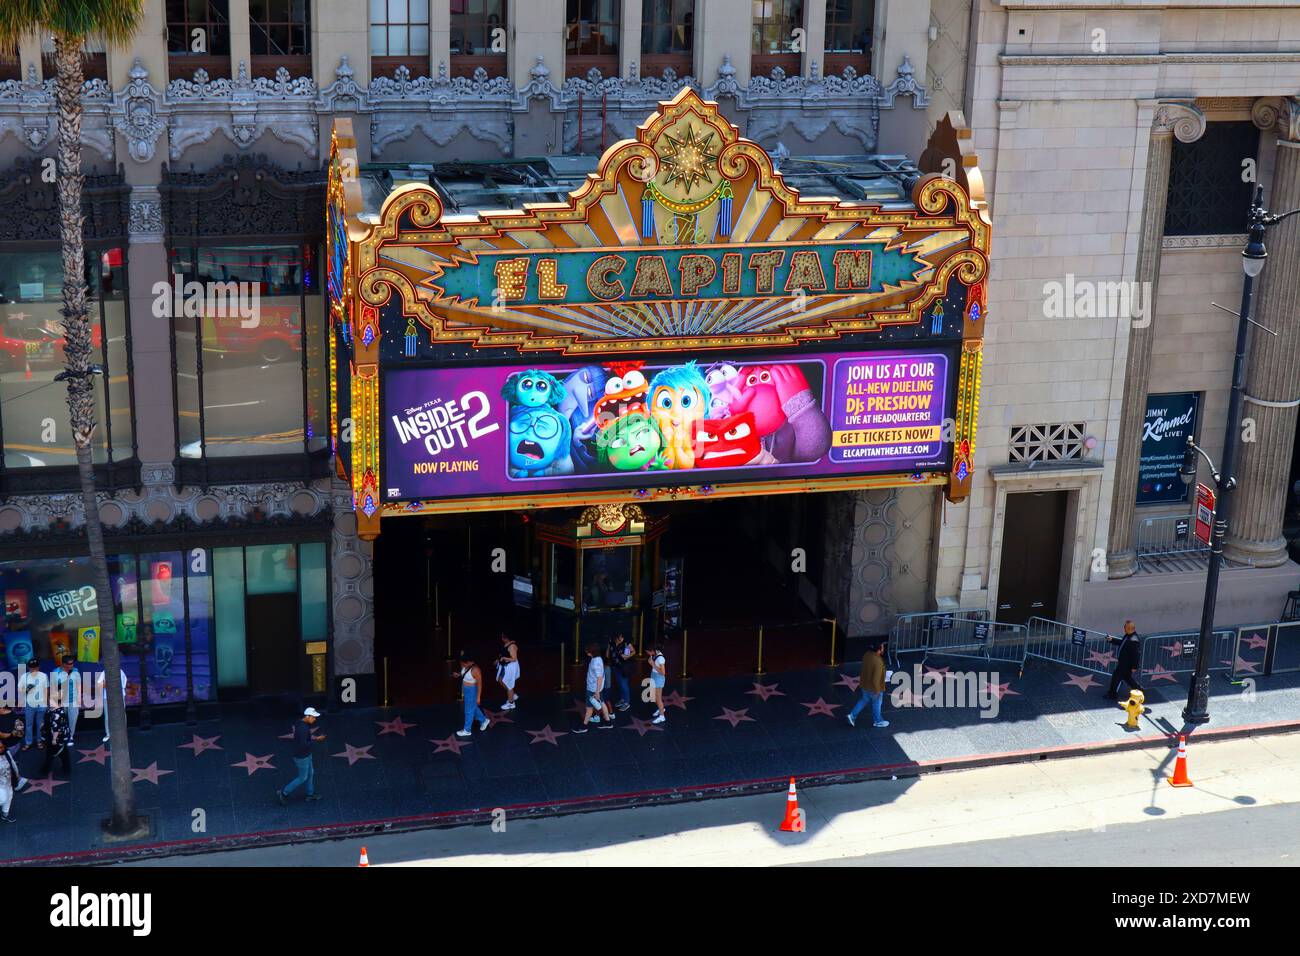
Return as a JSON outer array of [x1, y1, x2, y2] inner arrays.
[[381, 351, 953, 501]]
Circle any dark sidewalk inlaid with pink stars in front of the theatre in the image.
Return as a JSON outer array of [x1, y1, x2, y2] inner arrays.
[[0, 642, 1300, 862]]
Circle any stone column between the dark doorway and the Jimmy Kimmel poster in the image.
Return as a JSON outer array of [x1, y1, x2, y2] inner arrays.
[[1106, 100, 1205, 578]]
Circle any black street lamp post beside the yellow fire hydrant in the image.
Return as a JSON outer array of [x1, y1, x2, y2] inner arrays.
[[1179, 186, 1300, 724]]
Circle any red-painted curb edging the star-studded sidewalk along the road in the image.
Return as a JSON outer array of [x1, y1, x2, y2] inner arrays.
[[0, 721, 1300, 866]]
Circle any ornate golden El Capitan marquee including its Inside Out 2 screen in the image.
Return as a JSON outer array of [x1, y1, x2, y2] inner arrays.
[[328, 88, 989, 537]]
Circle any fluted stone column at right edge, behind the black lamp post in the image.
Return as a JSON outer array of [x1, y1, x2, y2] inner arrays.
[[1223, 96, 1300, 567]]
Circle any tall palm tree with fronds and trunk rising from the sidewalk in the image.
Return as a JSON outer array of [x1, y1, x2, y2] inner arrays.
[[0, 0, 144, 835]]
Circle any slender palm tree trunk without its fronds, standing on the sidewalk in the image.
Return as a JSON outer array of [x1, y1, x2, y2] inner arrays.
[[55, 36, 139, 835]]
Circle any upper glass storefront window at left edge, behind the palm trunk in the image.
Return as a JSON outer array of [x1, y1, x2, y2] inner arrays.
[[0, 248, 133, 468]]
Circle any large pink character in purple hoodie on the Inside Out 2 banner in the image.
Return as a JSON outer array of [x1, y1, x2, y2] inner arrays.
[[728, 365, 831, 464]]
